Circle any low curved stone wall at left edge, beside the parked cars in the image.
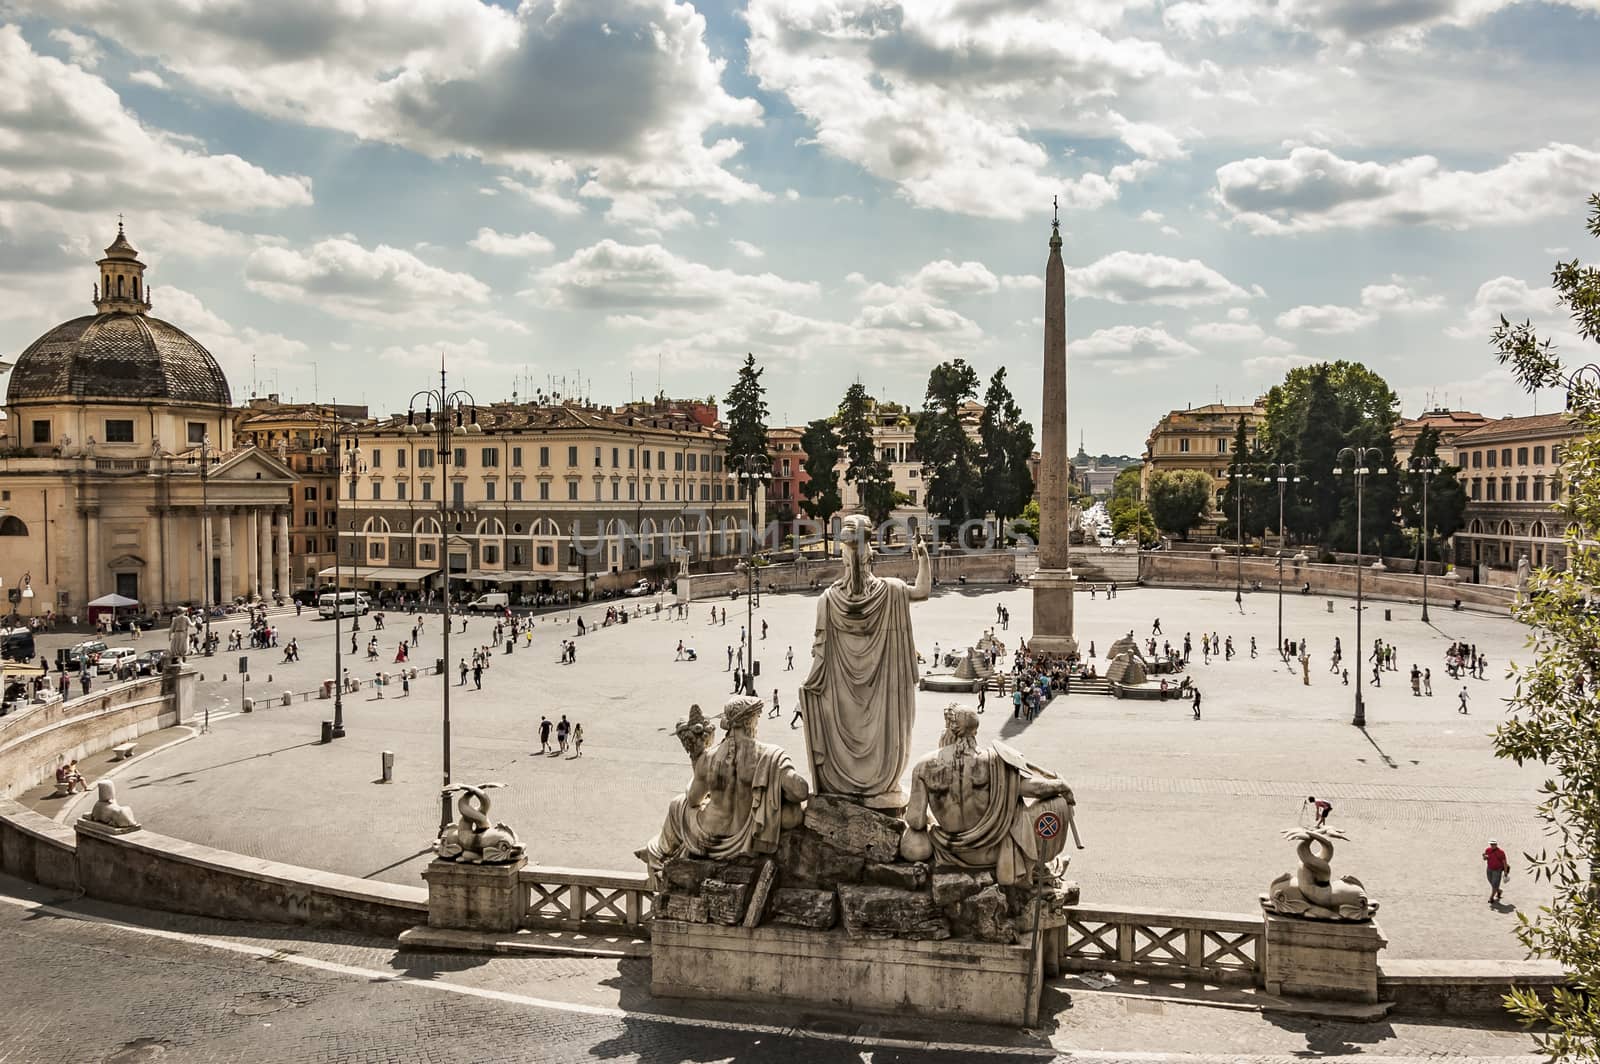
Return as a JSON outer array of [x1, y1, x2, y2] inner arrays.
[[0, 674, 194, 797]]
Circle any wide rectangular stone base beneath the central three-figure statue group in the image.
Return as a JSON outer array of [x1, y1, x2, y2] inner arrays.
[[650, 915, 1043, 1027]]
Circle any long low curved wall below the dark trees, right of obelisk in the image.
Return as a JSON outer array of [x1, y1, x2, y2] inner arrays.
[[1139, 550, 1514, 611]]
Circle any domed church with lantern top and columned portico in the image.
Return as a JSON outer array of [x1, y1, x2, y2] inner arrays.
[[0, 226, 296, 616]]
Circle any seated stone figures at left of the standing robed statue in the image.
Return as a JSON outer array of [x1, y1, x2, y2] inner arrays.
[[637, 694, 811, 878]]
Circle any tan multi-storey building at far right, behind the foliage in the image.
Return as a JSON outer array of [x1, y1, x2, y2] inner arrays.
[[1453, 414, 1574, 582]]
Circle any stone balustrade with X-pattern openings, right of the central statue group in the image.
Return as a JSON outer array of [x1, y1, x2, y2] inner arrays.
[[1056, 906, 1262, 984]]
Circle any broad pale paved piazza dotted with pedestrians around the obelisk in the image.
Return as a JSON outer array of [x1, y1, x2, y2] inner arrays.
[[46, 589, 1547, 958]]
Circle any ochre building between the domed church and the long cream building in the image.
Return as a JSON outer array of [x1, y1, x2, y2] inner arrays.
[[234, 395, 370, 594]]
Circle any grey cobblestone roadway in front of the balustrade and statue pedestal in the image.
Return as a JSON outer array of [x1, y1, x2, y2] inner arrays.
[[0, 877, 1536, 1064]]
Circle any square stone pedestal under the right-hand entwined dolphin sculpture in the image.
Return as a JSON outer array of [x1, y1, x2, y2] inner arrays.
[[1261, 912, 1389, 1005]]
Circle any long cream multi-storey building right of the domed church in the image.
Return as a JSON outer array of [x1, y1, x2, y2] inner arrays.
[[342, 403, 749, 594]]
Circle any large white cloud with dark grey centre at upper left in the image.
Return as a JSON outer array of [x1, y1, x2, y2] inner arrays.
[[27, 0, 766, 219]]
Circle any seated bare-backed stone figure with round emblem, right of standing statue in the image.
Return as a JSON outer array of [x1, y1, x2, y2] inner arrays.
[[901, 706, 1082, 886]]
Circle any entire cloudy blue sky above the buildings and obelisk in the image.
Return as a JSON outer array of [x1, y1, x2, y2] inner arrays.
[[0, 0, 1600, 453]]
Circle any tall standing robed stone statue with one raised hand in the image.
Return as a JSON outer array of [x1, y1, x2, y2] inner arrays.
[[800, 514, 933, 811]]
